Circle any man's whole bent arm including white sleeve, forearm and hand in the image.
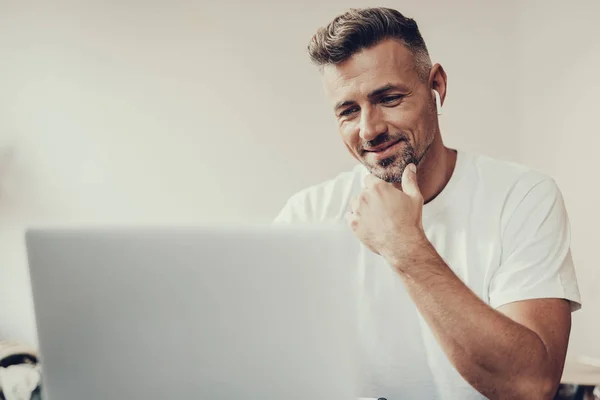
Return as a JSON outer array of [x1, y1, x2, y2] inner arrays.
[[347, 166, 579, 399]]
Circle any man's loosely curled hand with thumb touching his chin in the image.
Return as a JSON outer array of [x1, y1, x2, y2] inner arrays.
[[346, 164, 426, 272]]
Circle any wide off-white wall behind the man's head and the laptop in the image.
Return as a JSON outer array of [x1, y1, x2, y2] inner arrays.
[[0, 0, 540, 342]]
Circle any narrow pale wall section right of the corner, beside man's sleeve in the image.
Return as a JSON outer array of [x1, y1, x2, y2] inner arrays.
[[515, 0, 600, 358]]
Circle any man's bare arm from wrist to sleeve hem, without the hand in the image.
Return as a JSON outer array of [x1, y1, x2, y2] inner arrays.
[[401, 239, 571, 399]]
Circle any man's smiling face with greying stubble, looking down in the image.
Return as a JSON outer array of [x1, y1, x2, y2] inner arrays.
[[323, 40, 438, 182]]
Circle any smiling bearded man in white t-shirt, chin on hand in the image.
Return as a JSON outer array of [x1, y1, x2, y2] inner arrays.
[[276, 8, 580, 399]]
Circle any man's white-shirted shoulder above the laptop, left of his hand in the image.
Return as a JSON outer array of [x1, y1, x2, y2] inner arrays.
[[278, 164, 367, 222]]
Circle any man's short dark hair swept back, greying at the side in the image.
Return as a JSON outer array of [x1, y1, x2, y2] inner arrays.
[[308, 7, 431, 81]]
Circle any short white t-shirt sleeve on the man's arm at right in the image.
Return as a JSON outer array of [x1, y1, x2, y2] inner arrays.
[[489, 178, 581, 311]]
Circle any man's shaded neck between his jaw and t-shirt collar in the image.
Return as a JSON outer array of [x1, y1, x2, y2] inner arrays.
[[417, 135, 456, 203]]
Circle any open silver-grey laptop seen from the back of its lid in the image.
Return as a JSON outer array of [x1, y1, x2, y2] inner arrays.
[[26, 225, 360, 400]]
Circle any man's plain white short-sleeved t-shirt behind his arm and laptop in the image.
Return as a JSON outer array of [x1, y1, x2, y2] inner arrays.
[[275, 151, 581, 400]]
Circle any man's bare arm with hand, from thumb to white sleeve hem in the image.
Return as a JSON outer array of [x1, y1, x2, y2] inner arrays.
[[347, 162, 571, 399]]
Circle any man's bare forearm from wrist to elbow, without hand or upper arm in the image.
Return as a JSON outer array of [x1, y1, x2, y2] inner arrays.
[[397, 242, 554, 399]]
